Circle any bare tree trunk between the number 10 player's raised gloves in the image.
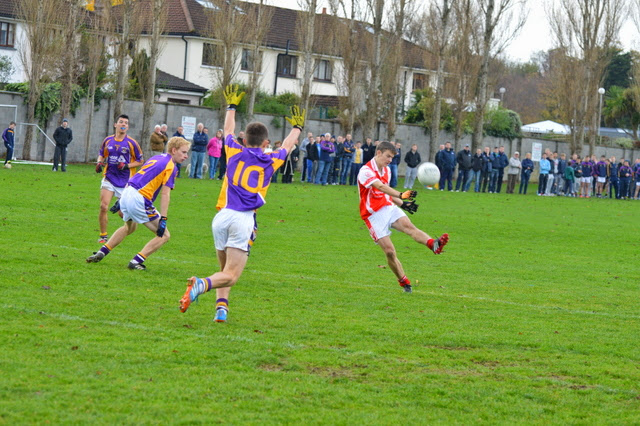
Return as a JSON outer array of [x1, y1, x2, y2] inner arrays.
[[247, 0, 273, 119]]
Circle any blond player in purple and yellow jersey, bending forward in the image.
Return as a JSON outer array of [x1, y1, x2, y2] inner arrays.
[[87, 137, 191, 270]]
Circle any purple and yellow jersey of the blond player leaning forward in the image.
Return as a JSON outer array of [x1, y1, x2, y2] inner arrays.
[[129, 154, 178, 205]]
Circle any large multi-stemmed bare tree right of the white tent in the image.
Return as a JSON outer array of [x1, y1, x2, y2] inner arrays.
[[549, 0, 628, 153]]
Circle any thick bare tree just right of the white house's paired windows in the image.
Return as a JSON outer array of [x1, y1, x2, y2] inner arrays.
[[330, 0, 367, 134]]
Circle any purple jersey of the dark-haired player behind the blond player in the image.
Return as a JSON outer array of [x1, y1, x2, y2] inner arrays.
[[98, 135, 142, 188]]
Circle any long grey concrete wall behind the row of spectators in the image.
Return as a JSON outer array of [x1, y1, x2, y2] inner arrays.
[[0, 92, 640, 175]]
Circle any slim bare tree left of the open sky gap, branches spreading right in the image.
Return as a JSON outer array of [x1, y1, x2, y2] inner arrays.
[[471, 0, 526, 151]]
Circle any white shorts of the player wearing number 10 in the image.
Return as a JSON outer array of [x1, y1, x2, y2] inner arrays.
[[211, 208, 258, 253]]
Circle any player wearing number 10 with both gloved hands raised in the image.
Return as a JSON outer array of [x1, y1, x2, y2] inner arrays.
[[180, 85, 306, 322]]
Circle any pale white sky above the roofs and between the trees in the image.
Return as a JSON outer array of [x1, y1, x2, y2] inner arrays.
[[252, 0, 640, 62]]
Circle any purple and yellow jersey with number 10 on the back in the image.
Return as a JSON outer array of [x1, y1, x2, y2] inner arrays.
[[216, 135, 287, 212]]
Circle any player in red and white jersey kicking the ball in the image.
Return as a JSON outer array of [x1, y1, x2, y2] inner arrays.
[[358, 142, 449, 293]]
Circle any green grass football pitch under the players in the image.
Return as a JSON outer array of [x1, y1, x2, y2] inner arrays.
[[0, 164, 640, 424]]
